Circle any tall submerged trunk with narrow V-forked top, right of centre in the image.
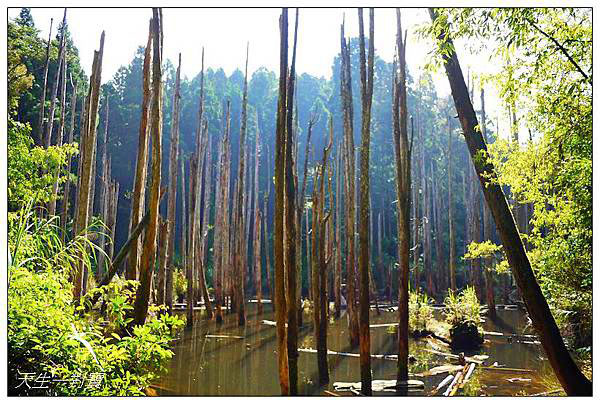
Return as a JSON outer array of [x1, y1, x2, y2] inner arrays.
[[358, 8, 375, 395]]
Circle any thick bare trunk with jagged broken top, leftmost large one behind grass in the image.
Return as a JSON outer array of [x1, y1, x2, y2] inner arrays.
[[73, 31, 104, 302]]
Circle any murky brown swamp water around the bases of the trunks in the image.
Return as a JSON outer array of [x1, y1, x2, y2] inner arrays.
[[157, 304, 555, 396]]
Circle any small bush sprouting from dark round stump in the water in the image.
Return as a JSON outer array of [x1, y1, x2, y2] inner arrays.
[[444, 287, 483, 349]]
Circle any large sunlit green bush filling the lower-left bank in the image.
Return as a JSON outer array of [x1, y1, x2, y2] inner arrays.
[[7, 201, 184, 396]]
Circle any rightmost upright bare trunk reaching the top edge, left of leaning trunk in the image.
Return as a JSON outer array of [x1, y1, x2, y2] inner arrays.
[[393, 8, 412, 384]]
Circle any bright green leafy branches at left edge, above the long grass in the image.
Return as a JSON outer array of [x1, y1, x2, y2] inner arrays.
[[7, 119, 77, 210]]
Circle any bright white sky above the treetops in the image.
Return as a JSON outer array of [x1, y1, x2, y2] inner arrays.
[[8, 8, 506, 134]]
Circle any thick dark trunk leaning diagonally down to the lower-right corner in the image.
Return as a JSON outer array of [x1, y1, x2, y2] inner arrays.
[[429, 9, 592, 395]]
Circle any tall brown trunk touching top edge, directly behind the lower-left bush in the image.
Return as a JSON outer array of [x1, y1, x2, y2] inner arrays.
[[133, 8, 163, 325]]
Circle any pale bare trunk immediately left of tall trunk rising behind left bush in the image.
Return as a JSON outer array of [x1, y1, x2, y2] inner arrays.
[[125, 23, 154, 280]]
